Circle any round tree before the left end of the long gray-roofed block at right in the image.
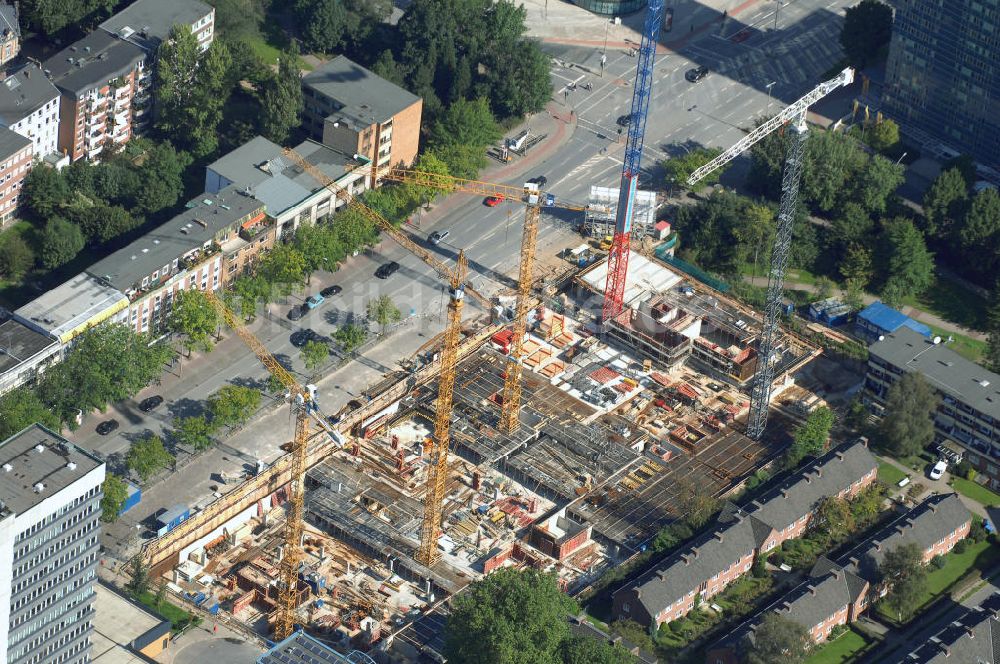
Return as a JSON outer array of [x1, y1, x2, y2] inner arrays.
[[879, 371, 938, 457]]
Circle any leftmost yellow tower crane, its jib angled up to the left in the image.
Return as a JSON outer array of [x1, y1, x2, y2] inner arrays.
[[202, 289, 315, 641]]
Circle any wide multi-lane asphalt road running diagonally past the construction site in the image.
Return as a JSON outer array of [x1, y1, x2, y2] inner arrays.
[[97, 0, 850, 556]]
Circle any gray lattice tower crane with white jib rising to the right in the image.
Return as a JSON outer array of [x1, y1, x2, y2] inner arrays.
[[687, 67, 854, 440]]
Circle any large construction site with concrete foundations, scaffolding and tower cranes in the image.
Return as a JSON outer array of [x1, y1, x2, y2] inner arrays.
[[131, 41, 851, 661]]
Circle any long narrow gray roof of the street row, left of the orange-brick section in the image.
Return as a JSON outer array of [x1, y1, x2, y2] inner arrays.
[[87, 188, 263, 292]]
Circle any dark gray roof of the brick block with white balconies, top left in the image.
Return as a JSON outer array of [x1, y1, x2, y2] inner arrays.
[[42, 30, 146, 98]]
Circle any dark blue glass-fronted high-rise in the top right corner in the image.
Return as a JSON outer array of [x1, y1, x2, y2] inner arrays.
[[883, 0, 1000, 167]]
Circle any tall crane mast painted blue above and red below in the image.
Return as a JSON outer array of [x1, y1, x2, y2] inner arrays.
[[601, 0, 663, 325]]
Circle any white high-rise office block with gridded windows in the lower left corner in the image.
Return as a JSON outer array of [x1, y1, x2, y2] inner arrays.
[[0, 424, 105, 664]]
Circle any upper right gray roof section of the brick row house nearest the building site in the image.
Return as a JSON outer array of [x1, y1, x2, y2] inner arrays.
[[744, 442, 878, 530]]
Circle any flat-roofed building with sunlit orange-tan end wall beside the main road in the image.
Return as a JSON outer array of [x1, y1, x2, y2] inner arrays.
[[302, 55, 423, 169]]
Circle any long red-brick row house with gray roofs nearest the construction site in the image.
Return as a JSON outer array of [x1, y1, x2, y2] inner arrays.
[[612, 439, 878, 630]]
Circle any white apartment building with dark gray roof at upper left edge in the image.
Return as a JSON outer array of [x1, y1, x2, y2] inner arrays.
[[0, 65, 60, 159]]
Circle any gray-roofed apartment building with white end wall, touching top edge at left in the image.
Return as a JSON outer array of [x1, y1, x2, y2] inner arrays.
[[99, 0, 215, 53]]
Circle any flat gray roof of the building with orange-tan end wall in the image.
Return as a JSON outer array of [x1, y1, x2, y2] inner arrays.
[[302, 55, 420, 127]]
